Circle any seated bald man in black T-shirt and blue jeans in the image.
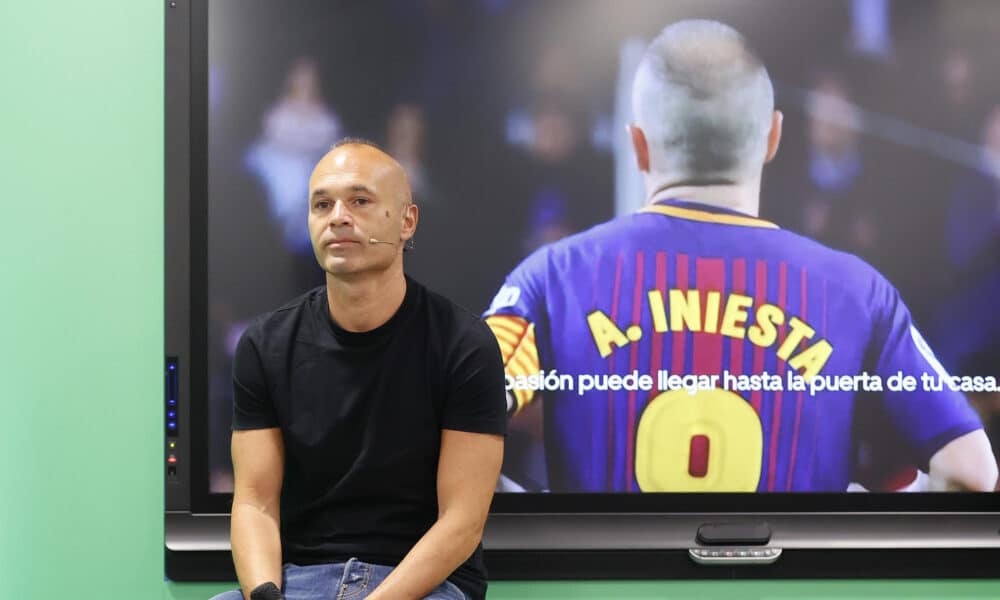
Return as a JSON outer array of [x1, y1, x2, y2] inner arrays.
[[217, 139, 506, 600]]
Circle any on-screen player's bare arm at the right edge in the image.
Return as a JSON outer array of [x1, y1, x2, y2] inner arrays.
[[928, 429, 997, 492]]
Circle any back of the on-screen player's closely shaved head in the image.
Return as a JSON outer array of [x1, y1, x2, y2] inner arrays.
[[632, 20, 774, 180]]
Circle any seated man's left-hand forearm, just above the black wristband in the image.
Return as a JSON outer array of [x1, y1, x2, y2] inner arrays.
[[230, 503, 281, 598]]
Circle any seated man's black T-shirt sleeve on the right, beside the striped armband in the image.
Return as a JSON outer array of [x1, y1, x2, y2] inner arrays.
[[442, 320, 507, 435]]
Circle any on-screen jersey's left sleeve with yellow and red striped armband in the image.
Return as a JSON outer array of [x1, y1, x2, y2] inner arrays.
[[483, 251, 547, 413]]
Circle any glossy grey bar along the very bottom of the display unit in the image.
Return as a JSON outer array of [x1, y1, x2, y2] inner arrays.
[[166, 513, 1000, 581]]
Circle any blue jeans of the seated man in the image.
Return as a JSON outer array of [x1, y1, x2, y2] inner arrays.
[[211, 558, 468, 600]]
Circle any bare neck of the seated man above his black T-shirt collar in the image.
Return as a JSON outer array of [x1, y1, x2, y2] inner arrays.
[[326, 266, 406, 332]]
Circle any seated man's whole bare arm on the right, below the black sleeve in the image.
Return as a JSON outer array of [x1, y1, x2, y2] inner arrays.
[[369, 429, 503, 600]]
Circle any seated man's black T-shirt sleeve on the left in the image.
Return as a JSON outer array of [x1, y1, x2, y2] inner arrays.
[[233, 326, 278, 431]]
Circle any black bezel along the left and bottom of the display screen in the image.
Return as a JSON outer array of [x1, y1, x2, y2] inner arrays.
[[165, 1, 1000, 516]]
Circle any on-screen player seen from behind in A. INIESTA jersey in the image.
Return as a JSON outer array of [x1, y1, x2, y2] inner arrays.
[[486, 20, 997, 492]]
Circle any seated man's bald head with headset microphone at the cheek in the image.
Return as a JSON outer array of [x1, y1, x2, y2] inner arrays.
[[309, 144, 417, 277]]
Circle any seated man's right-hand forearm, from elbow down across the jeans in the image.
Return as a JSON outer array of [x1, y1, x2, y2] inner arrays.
[[368, 510, 483, 600]]
